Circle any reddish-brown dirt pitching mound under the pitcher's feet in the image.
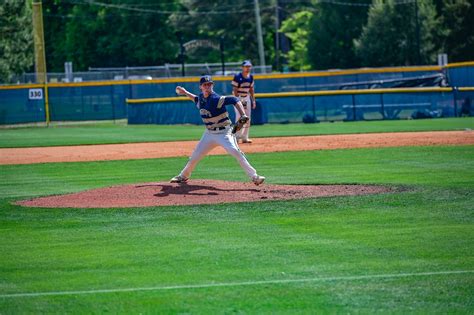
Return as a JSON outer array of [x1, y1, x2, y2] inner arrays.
[[16, 180, 391, 208]]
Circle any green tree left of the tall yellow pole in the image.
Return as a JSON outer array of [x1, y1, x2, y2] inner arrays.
[[0, 0, 34, 82]]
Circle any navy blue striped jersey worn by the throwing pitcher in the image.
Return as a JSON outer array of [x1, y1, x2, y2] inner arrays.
[[194, 92, 239, 129]]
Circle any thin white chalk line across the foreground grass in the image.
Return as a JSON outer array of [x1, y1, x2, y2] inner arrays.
[[0, 270, 474, 298]]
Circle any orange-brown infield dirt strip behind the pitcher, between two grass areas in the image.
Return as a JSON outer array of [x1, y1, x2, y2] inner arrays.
[[0, 131, 474, 165]]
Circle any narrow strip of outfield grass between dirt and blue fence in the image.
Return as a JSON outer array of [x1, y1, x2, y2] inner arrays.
[[0, 117, 474, 148]]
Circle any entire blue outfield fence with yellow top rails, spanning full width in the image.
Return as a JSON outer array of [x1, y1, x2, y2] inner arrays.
[[0, 62, 474, 125]]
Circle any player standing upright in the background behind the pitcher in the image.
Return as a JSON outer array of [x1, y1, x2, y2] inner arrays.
[[232, 60, 256, 143]]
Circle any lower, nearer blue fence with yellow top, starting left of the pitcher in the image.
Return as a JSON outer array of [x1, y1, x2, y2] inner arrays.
[[127, 88, 474, 124]]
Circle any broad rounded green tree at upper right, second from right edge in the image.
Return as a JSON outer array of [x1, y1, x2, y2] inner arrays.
[[354, 0, 439, 66]]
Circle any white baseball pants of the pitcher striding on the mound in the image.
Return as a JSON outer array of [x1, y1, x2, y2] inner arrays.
[[180, 126, 257, 178]]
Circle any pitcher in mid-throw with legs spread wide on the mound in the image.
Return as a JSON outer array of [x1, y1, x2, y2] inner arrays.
[[170, 76, 265, 186]]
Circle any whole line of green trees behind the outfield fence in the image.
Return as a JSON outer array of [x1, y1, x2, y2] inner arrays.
[[0, 0, 474, 82]]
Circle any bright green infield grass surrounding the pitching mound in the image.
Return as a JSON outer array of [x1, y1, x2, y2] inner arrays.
[[0, 146, 474, 314]]
